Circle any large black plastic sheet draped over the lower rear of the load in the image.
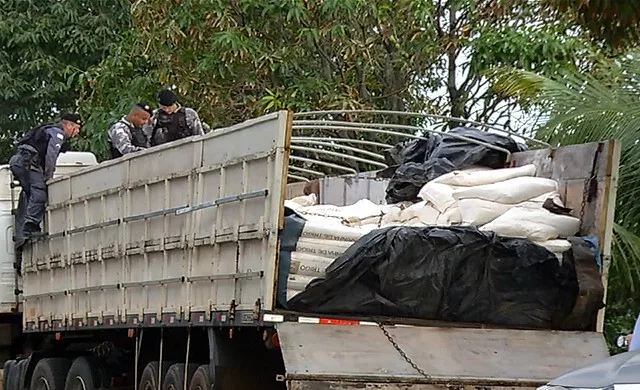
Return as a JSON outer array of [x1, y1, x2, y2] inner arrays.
[[288, 222, 578, 328]]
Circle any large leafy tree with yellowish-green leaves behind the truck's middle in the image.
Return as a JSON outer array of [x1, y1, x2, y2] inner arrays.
[[81, 0, 591, 159]]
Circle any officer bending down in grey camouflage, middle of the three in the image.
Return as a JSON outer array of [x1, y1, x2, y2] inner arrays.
[[107, 102, 152, 158]]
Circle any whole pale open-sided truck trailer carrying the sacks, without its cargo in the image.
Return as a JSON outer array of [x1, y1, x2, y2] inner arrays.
[[3, 111, 620, 390]]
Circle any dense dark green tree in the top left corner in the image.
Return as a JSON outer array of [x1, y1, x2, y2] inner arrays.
[[0, 0, 129, 161]]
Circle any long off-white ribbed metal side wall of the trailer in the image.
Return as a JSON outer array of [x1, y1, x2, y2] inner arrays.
[[23, 112, 290, 329]]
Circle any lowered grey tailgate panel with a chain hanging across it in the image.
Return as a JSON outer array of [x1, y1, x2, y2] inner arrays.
[[277, 322, 609, 390]]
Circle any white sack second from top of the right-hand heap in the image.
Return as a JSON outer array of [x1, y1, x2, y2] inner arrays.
[[453, 176, 558, 204]]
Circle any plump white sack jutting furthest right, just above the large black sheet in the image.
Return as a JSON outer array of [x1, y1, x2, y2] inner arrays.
[[480, 207, 580, 241]]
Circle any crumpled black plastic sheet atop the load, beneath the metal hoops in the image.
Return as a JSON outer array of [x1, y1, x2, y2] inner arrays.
[[378, 127, 526, 204]]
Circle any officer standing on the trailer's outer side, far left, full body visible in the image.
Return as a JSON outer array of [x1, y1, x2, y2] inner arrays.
[[9, 114, 82, 247]]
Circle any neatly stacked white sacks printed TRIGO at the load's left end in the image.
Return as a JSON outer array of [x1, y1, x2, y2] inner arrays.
[[285, 195, 382, 300]]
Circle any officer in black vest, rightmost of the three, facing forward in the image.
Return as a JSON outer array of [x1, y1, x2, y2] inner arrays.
[[145, 89, 204, 146]]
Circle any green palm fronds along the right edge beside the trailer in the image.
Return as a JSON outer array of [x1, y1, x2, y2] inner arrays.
[[499, 53, 640, 344]]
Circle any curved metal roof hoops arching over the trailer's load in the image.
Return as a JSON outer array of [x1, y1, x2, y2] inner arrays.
[[288, 110, 550, 182]]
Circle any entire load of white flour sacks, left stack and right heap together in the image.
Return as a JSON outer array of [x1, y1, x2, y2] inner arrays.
[[285, 165, 580, 286]]
